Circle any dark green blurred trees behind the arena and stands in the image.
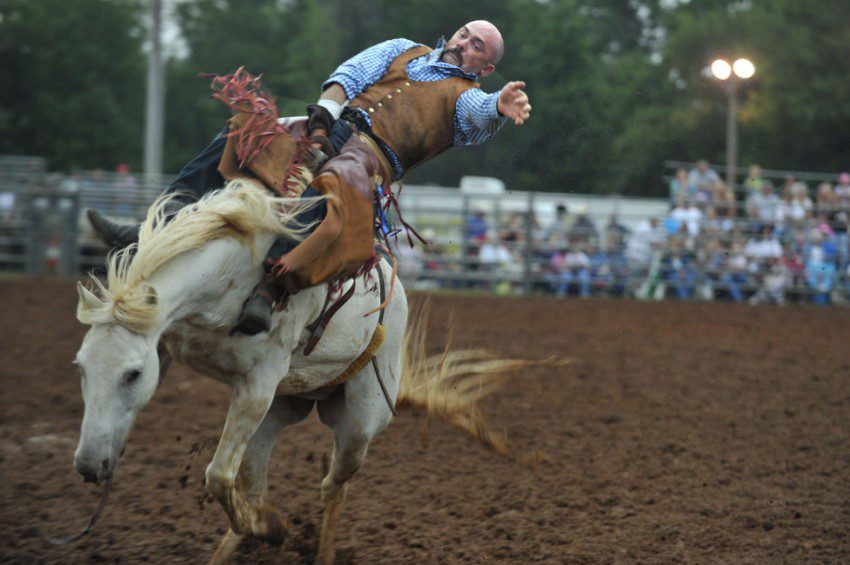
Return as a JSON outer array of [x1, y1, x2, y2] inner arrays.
[[0, 0, 850, 195]]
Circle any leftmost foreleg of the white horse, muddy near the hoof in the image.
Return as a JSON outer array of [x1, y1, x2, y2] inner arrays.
[[206, 368, 285, 543]]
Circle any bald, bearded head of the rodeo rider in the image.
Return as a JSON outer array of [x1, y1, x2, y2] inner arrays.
[[441, 20, 505, 77]]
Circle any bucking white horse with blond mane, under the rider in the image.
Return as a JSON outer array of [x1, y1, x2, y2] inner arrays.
[[74, 182, 408, 563]]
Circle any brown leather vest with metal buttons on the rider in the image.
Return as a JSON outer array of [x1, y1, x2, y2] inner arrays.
[[349, 45, 479, 172]]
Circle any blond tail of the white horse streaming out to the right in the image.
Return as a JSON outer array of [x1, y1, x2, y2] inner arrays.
[[396, 304, 566, 464]]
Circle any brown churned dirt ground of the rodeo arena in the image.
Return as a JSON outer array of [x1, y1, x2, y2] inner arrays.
[[0, 279, 850, 563]]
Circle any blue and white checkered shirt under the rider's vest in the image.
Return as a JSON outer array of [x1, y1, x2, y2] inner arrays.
[[322, 39, 506, 178]]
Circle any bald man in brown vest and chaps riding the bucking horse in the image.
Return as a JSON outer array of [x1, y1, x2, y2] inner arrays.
[[92, 20, 531, 335]]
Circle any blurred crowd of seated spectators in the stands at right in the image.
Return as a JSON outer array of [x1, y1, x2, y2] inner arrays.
[[400, 161, 850, 305]]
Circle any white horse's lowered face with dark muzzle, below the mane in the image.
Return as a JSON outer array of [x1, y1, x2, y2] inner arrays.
[[74, 302, 159, 483]]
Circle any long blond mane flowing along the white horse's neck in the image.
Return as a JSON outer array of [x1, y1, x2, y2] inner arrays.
[[77, 180, 317, 333]]
